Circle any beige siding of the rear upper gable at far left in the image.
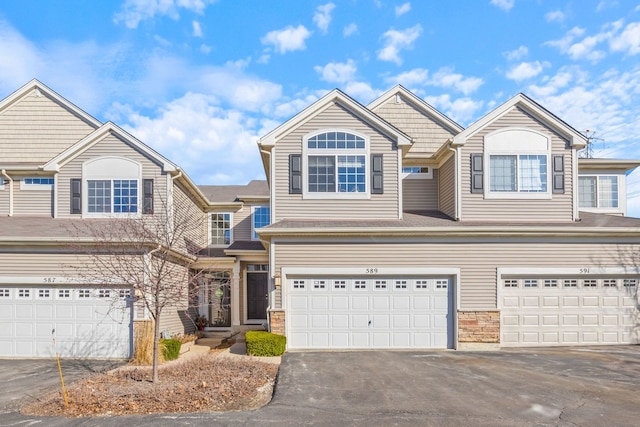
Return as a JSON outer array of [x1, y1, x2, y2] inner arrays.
[[0, 91, 95, 164]]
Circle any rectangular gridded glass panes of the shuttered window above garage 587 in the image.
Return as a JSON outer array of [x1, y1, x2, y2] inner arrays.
[[87, 179, 138, 214]]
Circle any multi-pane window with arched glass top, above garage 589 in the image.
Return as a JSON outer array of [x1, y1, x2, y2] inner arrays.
[[304, 131, 368, 198]]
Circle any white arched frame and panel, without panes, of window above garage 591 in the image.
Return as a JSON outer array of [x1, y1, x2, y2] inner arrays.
[[483, 128, 553, 199]]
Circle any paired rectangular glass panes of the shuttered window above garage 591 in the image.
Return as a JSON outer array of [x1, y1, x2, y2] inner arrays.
[[489, 154, 547, 193]]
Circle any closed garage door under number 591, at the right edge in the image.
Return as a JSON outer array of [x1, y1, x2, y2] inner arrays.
[[501, 277, 638, 347]]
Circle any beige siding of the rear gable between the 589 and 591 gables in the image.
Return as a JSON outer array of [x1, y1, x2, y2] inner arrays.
[[374, 95, 454, 159]]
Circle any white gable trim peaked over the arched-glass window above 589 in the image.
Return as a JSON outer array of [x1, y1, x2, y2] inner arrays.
[[258, 89, 411, 148]]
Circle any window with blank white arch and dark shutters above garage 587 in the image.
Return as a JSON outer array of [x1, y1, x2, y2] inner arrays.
[[81, 157, 145, 216]]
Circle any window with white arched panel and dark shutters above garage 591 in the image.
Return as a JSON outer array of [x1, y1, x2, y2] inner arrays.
[[471, 128, 564, 198]]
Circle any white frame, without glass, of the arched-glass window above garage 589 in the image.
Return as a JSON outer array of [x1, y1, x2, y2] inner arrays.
[[301, 128, 371, 199]]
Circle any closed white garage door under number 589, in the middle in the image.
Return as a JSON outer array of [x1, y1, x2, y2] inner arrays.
[[285, 277, 453, 349]]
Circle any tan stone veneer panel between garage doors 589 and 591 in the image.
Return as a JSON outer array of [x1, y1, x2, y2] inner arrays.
[[458, 311, 500, 349]]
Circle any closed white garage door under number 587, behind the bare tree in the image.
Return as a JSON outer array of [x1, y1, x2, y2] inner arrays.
[[0, 285, 132, 358]]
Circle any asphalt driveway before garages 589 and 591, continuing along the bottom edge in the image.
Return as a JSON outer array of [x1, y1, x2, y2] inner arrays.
[[0, 346, 640, 427]]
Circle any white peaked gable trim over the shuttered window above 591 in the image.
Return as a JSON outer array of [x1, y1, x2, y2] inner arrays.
[[453, 93, 587, 148]]
